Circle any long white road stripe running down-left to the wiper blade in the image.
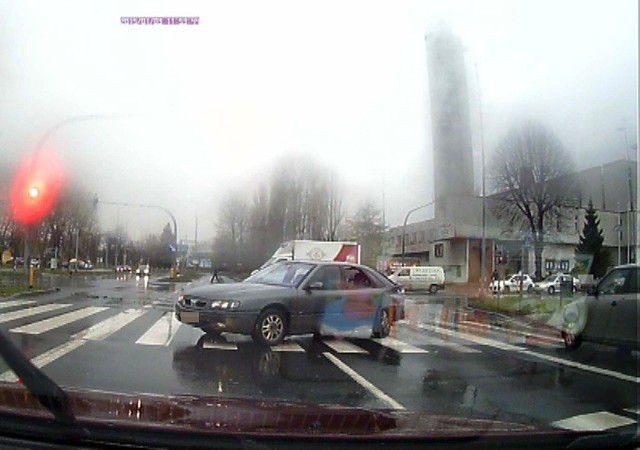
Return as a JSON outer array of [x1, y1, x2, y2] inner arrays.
[[0, 309, 145, 383]]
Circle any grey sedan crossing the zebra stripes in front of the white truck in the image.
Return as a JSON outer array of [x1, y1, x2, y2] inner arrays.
[[175, 261, 404, 345]]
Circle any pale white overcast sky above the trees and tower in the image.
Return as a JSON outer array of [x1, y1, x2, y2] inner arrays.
[[0, 0, 638, 243]]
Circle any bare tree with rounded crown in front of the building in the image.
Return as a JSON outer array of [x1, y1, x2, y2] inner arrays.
[[490, 122, 574, 277]]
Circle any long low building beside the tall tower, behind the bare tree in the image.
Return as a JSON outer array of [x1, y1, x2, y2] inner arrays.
[[384, 160, 639, 283]]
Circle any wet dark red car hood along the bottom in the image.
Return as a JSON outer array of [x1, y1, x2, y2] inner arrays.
[[0, 384, 549, 439]]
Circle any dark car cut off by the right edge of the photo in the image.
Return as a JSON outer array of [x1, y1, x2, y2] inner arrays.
[[562, 264, 640, 349]]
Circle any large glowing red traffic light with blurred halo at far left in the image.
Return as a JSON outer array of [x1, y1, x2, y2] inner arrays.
[[9, 151, 64, 225]]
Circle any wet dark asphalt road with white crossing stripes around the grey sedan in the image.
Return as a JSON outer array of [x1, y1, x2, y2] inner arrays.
[[0, 275, 640, 429]]
